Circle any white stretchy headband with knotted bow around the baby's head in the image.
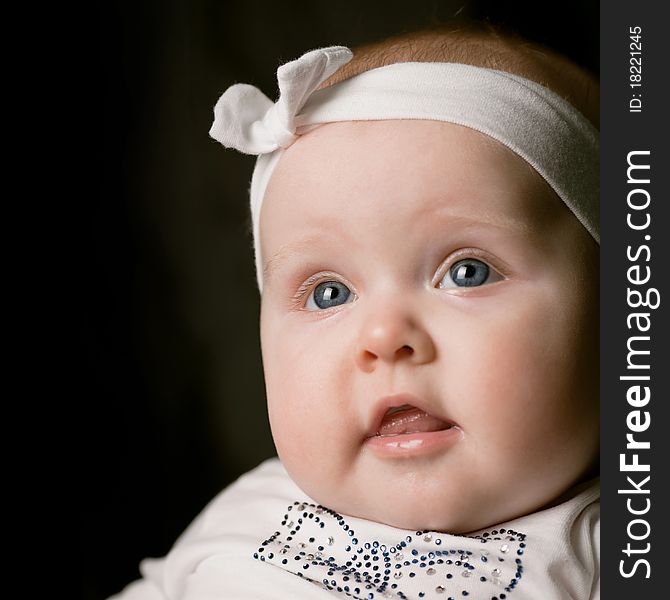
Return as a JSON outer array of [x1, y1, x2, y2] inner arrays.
[[209, 46, 600, 292]]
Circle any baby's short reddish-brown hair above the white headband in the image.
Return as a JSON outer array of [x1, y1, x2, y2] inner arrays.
[[321, 22, 600, 127]]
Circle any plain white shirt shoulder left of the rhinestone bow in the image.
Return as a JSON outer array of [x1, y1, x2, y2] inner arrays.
[[115, 457, 326, 600]]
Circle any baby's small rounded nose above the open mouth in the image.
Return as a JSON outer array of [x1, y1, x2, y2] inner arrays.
[[356, 308, 436, 372]]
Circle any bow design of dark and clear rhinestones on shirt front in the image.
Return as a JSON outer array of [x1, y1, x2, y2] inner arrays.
[[254, 502, 526, 600]]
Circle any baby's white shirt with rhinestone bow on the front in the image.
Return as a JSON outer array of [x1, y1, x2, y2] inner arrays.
[[110, 458, 600, 600]]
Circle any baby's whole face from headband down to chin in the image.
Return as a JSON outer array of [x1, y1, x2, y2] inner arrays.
[[260, 120, 599, 533]]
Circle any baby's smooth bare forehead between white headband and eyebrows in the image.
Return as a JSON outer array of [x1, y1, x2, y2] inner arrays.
[[261, 120, 567, 236]]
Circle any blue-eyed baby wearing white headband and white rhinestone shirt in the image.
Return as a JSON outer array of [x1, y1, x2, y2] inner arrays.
[[113, 22, 599, 600]]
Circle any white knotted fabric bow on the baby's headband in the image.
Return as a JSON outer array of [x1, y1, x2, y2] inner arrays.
[[209, 46, 353, 154]]
